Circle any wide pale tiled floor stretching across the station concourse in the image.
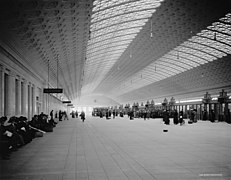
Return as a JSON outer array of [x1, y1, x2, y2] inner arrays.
[[0, 117, 231, 180]]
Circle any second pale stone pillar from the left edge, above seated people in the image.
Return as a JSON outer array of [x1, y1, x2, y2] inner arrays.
[[5, 72, 15, 116]]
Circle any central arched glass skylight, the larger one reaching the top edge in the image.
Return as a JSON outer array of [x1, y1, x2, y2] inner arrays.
[[82, 0, 163, 93]]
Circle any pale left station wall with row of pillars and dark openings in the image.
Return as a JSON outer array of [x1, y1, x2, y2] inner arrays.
[[0, 48, 67, 120]]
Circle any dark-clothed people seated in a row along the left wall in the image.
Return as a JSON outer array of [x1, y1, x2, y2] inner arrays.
[[0, 110, 68, 160]]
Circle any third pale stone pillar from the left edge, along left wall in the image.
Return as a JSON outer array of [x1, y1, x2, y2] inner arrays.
[[21, 80, 28, 117]]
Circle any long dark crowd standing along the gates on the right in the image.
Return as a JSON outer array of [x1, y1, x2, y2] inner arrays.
[[92, 107, 231, 124]]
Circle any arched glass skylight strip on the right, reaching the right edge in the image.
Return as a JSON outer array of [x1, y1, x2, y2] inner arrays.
[[113, 13, 231, 95]]
